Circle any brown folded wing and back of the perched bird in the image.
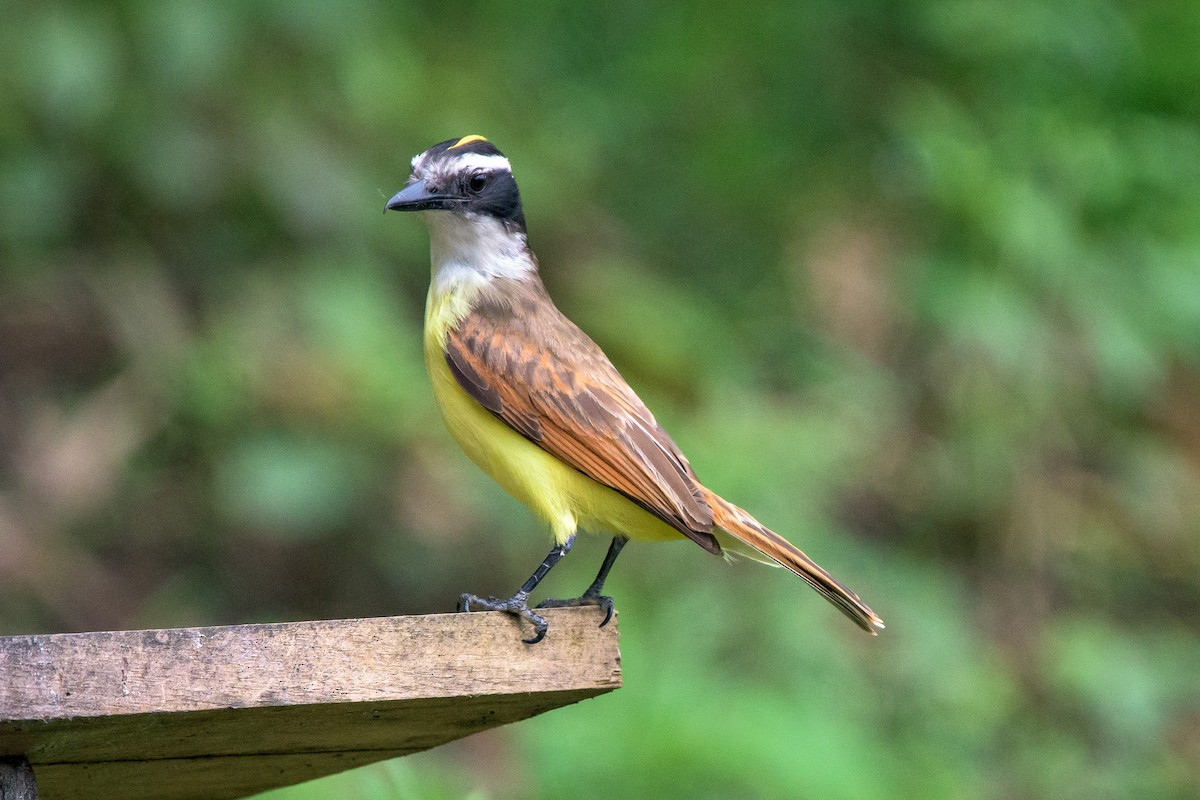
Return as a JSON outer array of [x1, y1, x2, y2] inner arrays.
[[445, 281, 721, 553]]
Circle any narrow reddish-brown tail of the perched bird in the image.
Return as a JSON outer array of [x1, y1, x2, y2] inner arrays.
[[703, 489, 883, 636]]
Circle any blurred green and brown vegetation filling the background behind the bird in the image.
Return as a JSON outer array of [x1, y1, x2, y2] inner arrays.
[[0, 0, 1200, 800]]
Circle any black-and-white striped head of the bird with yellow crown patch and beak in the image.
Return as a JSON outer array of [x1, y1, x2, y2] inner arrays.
[[388, 134, 524, 233]]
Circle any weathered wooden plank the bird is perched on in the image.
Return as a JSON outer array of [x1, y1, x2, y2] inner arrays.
[[0, 608, 620, 800]]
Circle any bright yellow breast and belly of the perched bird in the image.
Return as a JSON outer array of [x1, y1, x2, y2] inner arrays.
[[425, 291, 683, 543]]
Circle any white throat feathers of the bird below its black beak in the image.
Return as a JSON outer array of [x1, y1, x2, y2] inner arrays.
[[421, 211, 538, 294]]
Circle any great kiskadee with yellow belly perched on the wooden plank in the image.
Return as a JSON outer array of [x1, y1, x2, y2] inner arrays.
[[388, 136, 883, 644]]
